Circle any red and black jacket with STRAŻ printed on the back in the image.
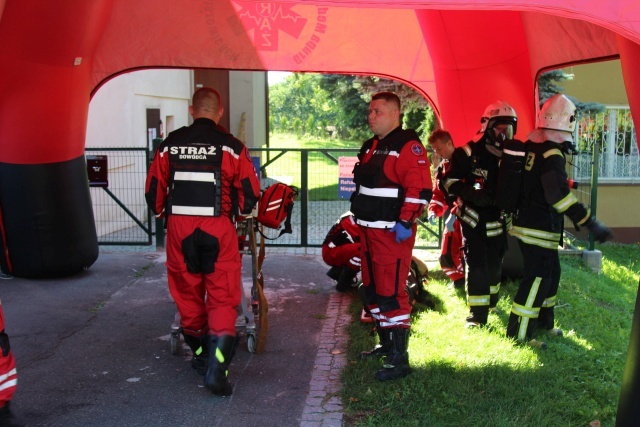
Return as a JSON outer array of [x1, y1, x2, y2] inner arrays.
[[145, 118, 260, 218]]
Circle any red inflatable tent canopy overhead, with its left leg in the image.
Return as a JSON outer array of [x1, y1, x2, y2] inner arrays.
[[0, 0, 640, 270]]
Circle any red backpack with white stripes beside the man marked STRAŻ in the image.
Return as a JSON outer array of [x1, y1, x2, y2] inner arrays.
[[257, 182, 298, 239]]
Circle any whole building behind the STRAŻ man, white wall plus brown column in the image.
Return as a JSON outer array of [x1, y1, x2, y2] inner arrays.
[[85, 69, 267, 241]]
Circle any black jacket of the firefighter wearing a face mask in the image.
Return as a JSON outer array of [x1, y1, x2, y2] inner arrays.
[[444, 136, 502, 231]]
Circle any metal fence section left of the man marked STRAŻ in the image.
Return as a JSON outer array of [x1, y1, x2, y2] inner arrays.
[[85, 147, 153, 245]]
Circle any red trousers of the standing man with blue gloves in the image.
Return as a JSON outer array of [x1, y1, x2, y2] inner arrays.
[[360, 225, 416, 329]]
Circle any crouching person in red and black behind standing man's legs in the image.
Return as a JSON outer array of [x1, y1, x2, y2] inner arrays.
[[322, 212, 360, 292]]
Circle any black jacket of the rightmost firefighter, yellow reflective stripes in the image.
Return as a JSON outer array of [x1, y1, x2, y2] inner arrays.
[[510, 141, 591, 250]]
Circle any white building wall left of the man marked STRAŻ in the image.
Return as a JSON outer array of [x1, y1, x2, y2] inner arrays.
[[85, 70, 193, 241]]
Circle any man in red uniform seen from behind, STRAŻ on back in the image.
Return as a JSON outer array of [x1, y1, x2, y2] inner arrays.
[[145, 87, 260, 396]]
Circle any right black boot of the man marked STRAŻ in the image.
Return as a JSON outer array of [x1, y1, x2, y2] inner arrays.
[[204, 335, 236, 396]]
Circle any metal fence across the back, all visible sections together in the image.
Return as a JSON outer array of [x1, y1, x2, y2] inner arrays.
[[85, 147, 441, 248]]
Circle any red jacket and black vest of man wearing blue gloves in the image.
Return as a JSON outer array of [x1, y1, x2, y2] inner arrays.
[[351, 127, 432, 228]]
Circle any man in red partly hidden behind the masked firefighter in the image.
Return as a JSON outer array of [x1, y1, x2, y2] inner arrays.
[[427, 129, 464, 289]]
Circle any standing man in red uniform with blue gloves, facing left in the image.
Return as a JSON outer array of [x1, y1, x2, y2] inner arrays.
[[351, 92, 432, 380]]
